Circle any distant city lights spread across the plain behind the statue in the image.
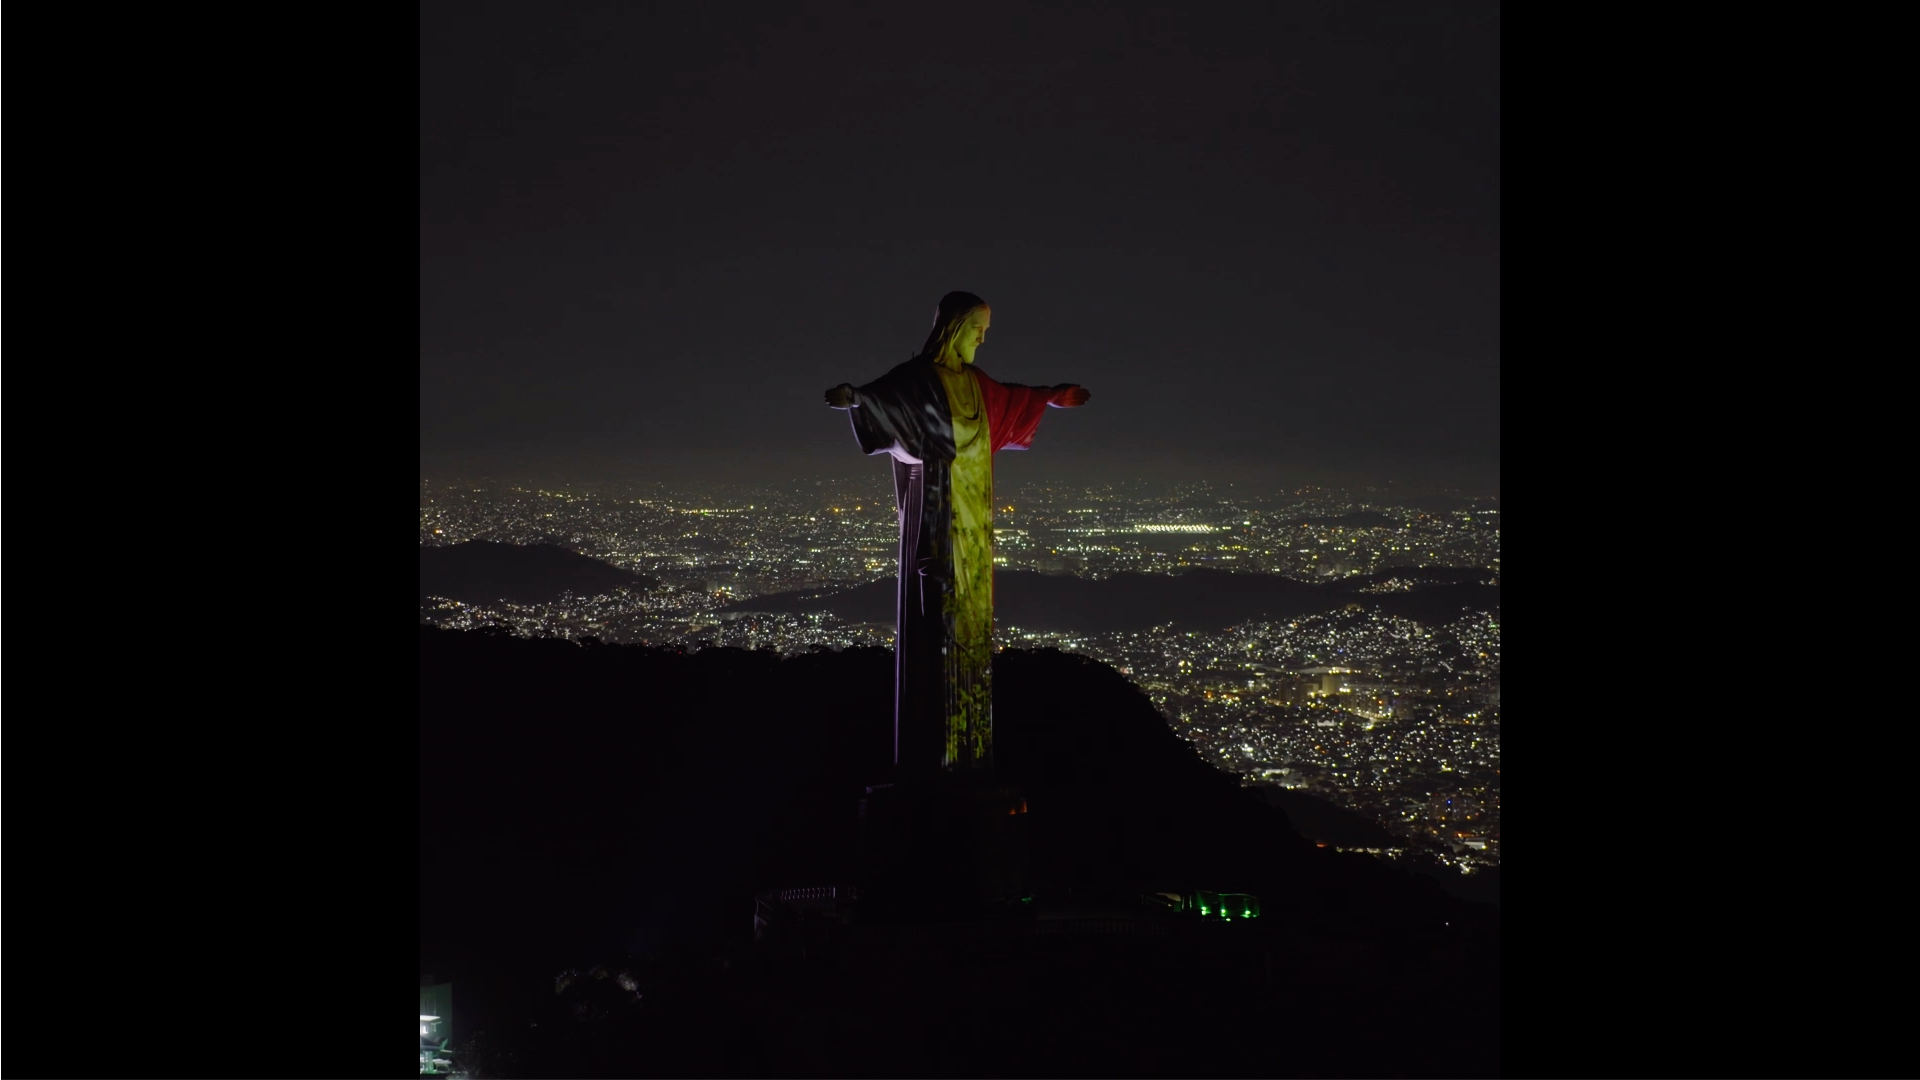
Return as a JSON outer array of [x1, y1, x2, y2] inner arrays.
[[420, 471, 1500, 874]]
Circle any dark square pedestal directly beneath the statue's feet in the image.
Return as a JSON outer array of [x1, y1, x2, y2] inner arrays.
[[860, 778, 1029, 922]]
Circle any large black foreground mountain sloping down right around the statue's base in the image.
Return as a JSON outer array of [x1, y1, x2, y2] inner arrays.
[[420, 626, 1498, 1076]]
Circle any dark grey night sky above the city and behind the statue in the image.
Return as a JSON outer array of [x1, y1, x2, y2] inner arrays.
[[420, 0, 1500, 492]]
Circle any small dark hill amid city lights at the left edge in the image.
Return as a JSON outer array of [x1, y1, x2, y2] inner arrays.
[[420, 540, 653, 603]]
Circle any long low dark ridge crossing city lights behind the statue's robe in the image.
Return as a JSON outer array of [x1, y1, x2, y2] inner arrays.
[[726, 567, 1500, 634]]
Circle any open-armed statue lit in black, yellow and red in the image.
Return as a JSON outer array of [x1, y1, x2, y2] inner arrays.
[[826, 292, 1089, 774]]
